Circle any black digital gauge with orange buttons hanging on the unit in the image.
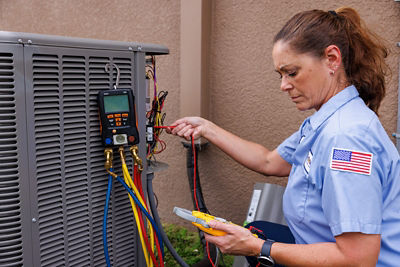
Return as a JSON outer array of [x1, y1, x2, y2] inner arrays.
[[97, 89, 139, 149]]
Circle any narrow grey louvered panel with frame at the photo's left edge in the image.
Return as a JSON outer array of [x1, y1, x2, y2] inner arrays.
[[0, 43, 32, 266]]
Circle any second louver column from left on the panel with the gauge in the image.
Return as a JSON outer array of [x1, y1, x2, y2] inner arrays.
[[62, 56, 90, 266]]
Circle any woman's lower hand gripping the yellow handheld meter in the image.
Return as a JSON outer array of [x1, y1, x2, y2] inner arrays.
[[204, 221, 264, 256]]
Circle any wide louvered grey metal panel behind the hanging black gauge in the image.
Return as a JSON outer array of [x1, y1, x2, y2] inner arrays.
[[25, 45, 139, 266]]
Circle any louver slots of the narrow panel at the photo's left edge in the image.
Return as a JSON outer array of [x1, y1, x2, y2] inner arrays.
[[0, 52, 23, 266]]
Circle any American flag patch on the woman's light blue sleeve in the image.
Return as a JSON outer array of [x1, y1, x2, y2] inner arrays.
[[331, 147, 372, 175]]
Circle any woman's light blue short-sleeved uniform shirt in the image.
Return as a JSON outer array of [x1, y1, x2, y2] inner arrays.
[[278, 86, 400, 266]]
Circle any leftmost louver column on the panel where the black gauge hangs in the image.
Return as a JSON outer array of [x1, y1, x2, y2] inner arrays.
[[32, 55, 66, 266]]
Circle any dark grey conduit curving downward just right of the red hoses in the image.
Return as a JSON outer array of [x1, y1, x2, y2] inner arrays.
[[147, 173, 189, 267]]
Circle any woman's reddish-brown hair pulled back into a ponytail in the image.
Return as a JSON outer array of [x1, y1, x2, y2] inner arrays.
[[274, 7, 388, 113]]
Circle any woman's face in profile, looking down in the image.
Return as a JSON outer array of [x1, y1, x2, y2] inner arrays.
[[272, 41, 332, 110]]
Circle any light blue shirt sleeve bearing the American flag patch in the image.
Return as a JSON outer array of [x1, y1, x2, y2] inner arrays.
[[317, 130, 383, 236]]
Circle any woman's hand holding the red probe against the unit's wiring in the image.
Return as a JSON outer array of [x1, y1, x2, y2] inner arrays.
[[167, 117, 212, 140]]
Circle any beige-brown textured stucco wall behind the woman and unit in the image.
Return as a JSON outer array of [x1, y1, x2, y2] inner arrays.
[[0, 0, 400, 228]]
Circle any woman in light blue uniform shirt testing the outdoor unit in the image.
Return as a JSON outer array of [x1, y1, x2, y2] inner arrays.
[[172, 8, 400, 266]]
